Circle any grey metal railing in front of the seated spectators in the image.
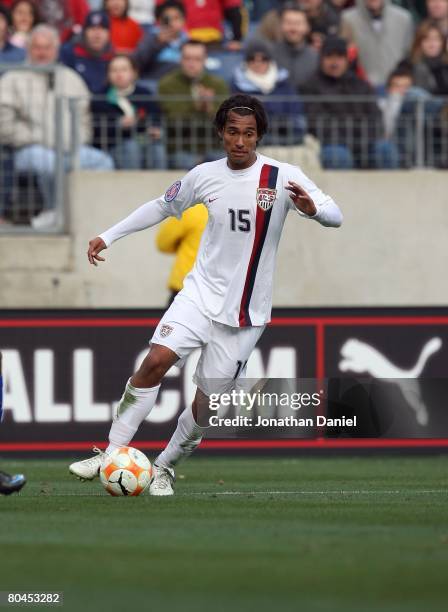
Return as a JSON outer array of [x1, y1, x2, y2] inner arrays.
[[0, 67, 448, 232]]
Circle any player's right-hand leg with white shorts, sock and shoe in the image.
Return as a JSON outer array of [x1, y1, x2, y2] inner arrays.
[[150, 322, 264, 495]]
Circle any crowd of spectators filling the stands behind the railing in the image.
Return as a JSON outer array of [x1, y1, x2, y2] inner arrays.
[[0, 0, 448, 225]]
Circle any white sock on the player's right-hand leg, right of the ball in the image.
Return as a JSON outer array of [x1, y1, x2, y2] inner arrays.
[[154, 406, 204, 467]]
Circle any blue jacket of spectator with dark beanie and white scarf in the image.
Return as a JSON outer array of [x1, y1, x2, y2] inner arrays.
[[231, 64, 306, 144]]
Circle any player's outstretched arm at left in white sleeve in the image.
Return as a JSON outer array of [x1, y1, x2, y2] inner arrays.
[[87, 168, 200, 266]]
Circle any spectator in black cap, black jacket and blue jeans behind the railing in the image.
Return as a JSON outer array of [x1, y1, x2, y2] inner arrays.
[[304, 37, 396, 169]]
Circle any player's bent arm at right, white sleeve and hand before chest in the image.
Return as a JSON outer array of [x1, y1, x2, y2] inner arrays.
[[285, 173, 343, 227]]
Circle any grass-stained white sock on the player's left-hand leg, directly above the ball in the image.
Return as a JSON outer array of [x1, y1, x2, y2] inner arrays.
[[106, 379, 160, 453]]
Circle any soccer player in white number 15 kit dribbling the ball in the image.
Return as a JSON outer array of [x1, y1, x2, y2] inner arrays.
[[70, 95, 342, 495]]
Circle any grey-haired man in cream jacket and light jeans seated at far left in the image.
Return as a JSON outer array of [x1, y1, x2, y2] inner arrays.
[[0, 25, 113, 229]]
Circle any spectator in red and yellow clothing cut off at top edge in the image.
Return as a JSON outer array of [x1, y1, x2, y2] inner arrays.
[[177, 0, 243, 51]]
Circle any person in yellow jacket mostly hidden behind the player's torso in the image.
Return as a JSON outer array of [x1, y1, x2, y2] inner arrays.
[[156, 204, 208, 304]]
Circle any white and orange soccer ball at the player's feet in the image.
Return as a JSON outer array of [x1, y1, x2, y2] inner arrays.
[[100, 446, 152, 496]]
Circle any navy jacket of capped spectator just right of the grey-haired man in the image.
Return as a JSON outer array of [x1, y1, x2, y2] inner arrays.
[[59, 40, 114, 93]]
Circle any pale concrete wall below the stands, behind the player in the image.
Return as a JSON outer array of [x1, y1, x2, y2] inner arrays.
[[0, 170, 448, 308]]
